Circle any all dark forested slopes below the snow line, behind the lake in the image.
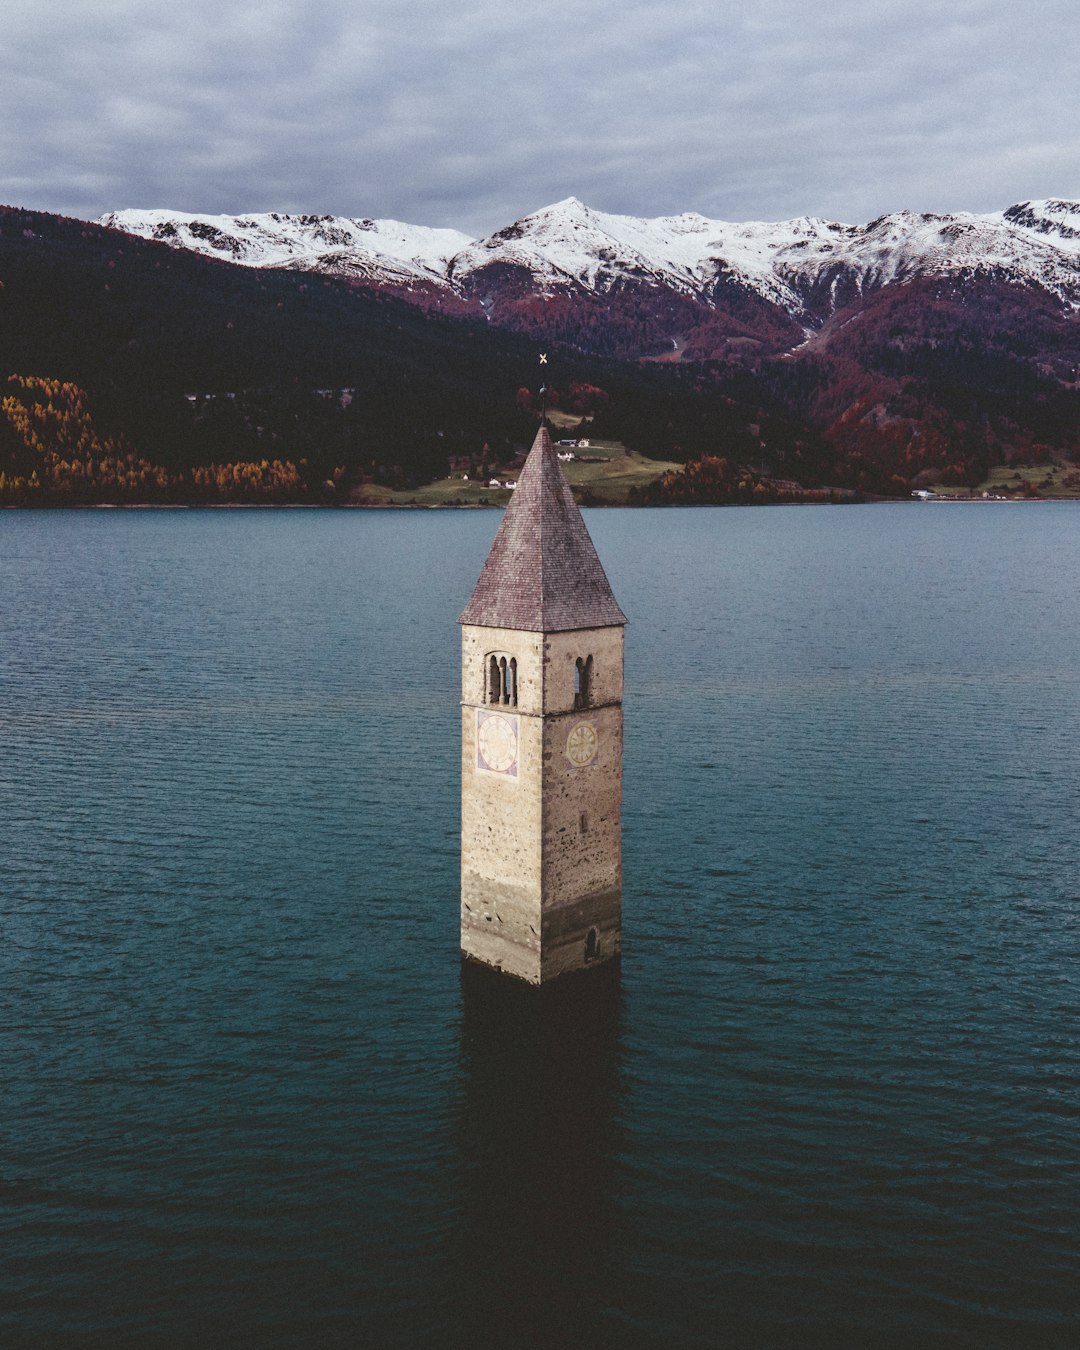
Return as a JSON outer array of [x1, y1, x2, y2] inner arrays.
[[0, 208, 1080, 504]]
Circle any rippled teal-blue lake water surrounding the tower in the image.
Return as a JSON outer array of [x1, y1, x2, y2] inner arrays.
[[0, 504, 1080, 1347]]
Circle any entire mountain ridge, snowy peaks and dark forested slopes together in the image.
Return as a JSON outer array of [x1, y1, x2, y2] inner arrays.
[[0, 198, 1080, 507]]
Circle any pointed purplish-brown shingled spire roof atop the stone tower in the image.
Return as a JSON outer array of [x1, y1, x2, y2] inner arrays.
[[460, 424, 626, 633]]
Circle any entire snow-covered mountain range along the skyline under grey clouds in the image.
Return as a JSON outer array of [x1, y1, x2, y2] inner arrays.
[[101, 197, 1080, 327]]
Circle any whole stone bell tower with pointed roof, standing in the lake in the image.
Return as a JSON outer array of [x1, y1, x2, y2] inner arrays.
[[460, 425, 626, 984]]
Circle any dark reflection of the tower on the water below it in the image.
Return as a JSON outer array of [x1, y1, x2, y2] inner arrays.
[[454, 960, 622, 1346]]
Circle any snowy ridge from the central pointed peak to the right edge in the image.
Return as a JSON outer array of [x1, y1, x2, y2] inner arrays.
[[451, 197, 1080, 317]]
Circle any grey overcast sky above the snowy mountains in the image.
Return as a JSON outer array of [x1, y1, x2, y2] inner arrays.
[[0, 0, 1080, 235]]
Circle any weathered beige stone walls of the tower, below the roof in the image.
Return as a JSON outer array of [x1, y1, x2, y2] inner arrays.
[[462, 626, 622, 983]]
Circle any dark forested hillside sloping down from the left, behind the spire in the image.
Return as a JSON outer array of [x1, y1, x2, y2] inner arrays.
[[0, 208, 826, 502]]
